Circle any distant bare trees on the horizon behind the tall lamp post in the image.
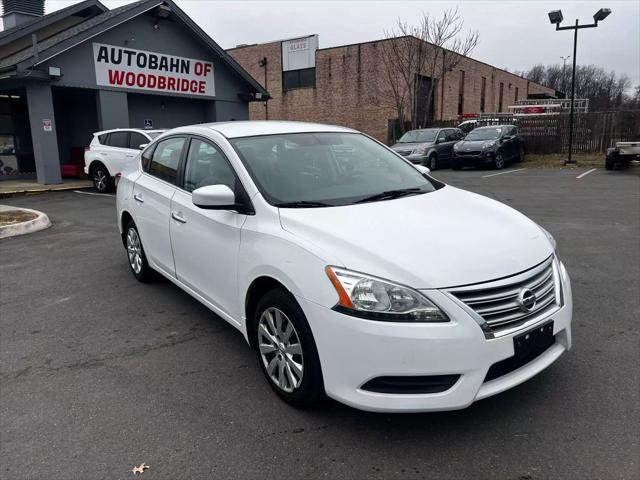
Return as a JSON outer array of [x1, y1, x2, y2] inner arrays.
[[515, 64, 640, 112]]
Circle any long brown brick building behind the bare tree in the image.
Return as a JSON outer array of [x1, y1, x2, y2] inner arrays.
[[227, 35, 556, 142]]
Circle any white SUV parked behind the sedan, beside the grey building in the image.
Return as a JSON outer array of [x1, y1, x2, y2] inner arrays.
[[84, 128, 166, 193]]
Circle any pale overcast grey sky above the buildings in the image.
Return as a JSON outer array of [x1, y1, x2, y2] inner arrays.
[[45, 0, 640, 85]]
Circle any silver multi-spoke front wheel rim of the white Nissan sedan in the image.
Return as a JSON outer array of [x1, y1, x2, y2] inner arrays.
[[258, 307, 304, 393]]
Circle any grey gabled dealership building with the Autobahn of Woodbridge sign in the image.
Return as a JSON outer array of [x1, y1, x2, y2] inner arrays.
[[0, 0, 268, 184]]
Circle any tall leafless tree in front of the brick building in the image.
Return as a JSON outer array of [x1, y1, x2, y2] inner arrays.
[[381, 8, 479, 131]]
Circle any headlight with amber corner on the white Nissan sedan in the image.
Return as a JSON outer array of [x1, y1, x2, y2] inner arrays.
[[325, 267, 449, 322]]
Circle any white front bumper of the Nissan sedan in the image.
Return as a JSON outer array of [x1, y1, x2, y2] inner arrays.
[[299, 262, 573, 412]]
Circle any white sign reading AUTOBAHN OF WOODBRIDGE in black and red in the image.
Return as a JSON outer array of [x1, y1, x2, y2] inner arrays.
[[93, 43, 215, 97]]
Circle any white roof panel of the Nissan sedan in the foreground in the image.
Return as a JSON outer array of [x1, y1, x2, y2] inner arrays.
[[185, 120, 356, 138]]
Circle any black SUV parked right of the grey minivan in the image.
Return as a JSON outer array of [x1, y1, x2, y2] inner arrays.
[[451, 125, 524, 170]]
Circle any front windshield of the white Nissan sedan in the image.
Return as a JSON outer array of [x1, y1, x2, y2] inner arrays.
[[230, 132, 444, 208]]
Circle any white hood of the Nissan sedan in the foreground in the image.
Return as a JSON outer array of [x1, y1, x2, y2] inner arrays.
[[280, 186, 553, 288]]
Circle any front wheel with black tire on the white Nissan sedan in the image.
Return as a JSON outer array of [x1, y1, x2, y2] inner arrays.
[[252, 289, 324, 407]]
